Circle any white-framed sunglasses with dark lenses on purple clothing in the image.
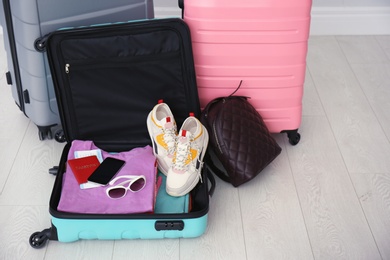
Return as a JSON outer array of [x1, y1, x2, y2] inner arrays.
[[106, 175, 146, 199]]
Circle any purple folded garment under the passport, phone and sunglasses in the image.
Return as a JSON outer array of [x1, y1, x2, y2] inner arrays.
[[57, 140, 157, 214]]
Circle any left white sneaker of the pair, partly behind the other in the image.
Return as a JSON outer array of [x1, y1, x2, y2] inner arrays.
[[146, 100, 177, 175]]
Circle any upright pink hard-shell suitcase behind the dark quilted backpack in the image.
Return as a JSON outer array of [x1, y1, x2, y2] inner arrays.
[[179, 0, 312, 145]]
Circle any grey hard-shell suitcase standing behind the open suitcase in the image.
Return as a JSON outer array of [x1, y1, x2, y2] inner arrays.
[[0, 0, 154, 141]]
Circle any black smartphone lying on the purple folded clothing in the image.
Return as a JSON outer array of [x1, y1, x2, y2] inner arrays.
[[88, 157, 125, 185]]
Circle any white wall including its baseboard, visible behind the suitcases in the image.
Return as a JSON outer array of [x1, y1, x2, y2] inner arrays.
[[154, 0, 390, 35]]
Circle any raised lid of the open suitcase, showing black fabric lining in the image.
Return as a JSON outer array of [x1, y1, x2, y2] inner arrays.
[[46, 18, 200, 152]]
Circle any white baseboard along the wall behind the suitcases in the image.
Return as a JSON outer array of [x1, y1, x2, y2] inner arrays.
[[155, 6, 390, 35]]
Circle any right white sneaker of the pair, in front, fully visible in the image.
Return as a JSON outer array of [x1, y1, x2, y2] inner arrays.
[[166, 116, 209, 197]]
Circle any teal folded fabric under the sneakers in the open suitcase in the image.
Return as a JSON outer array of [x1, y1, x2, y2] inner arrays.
[[154, 171, 190, 214]]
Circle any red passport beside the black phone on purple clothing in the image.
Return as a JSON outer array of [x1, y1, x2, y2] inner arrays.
[[68, 155, 100, 184]]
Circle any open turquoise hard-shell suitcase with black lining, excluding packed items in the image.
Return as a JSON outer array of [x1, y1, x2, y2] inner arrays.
[[30, 19, 215, 248]]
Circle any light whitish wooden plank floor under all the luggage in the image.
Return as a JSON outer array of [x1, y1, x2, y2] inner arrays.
[[0, 36, 390, 260]]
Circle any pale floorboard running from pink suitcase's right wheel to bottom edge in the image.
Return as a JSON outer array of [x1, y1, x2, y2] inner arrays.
[[286, 117, 380, 259]]
